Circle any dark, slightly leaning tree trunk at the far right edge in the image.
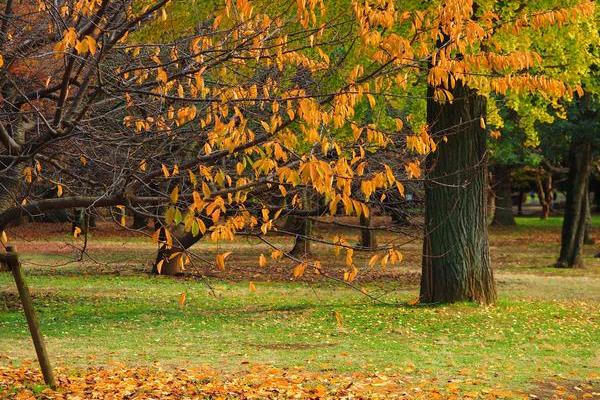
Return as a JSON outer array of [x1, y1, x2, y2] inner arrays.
[[556, 135, 592, 268]]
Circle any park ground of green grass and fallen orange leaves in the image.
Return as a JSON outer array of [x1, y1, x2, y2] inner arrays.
[[0, 217, 600, 399]]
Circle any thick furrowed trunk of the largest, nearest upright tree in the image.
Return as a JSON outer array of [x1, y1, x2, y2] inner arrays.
[[420, 81, 496, 304]]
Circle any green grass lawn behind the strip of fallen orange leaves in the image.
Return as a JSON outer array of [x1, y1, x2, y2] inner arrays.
[[0, 218, 600, 396]]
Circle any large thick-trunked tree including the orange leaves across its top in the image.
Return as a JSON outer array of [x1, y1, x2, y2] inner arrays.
[[357, 1, 594, 303]]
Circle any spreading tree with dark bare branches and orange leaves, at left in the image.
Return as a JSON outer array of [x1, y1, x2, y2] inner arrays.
[[0, 0, 421, 280]]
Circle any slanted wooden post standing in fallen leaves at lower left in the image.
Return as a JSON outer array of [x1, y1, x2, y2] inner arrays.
[[5, 246, 56, 388]]
